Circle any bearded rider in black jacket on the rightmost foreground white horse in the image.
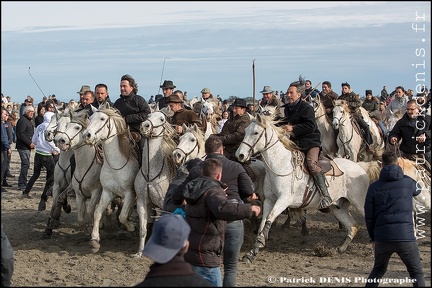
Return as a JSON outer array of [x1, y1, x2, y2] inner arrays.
[[281, 78, 332, 209]]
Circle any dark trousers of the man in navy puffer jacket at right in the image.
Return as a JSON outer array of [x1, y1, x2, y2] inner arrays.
[[365, 241, 425, 287]]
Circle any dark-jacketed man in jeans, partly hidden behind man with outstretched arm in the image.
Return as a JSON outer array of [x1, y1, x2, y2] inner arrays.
[[173, 135, 258, 287]]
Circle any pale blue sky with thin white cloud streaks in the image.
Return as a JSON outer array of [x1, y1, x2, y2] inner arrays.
[[1, 1, 431, 102]]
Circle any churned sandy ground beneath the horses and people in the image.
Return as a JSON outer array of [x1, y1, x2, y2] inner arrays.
[[1, 144, 431, 287]]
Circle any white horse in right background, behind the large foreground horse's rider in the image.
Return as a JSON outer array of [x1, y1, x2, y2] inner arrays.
[[332, 100, 385, 162]]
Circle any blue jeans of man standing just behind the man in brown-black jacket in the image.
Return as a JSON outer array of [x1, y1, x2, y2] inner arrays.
[[223, 220, 244, 287]]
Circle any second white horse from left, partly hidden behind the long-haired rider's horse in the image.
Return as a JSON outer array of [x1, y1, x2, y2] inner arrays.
[[55, 110, 102, 234]]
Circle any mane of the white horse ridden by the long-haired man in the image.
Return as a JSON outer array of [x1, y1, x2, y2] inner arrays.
[[98, 105, 133, 158]]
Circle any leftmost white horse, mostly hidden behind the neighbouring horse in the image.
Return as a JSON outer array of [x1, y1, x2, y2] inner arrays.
[[43, 108, 73, 238]]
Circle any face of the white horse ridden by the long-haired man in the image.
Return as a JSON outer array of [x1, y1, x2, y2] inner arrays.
[[82, 111, 109, 145]]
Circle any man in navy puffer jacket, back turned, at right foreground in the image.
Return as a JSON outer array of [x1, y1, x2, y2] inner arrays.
[[364, 151, 425, 287]]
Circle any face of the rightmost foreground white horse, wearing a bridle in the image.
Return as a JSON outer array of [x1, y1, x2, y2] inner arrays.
[[235, 121, 266, 162]]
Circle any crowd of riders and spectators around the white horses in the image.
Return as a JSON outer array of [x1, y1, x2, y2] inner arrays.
[[1, 74, 431, 287]]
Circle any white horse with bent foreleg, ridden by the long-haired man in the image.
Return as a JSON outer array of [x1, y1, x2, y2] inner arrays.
[[82, 104, 139, 252]]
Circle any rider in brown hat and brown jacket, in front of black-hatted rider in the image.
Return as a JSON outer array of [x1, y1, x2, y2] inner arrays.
[[166, 94, 204, 134]]
